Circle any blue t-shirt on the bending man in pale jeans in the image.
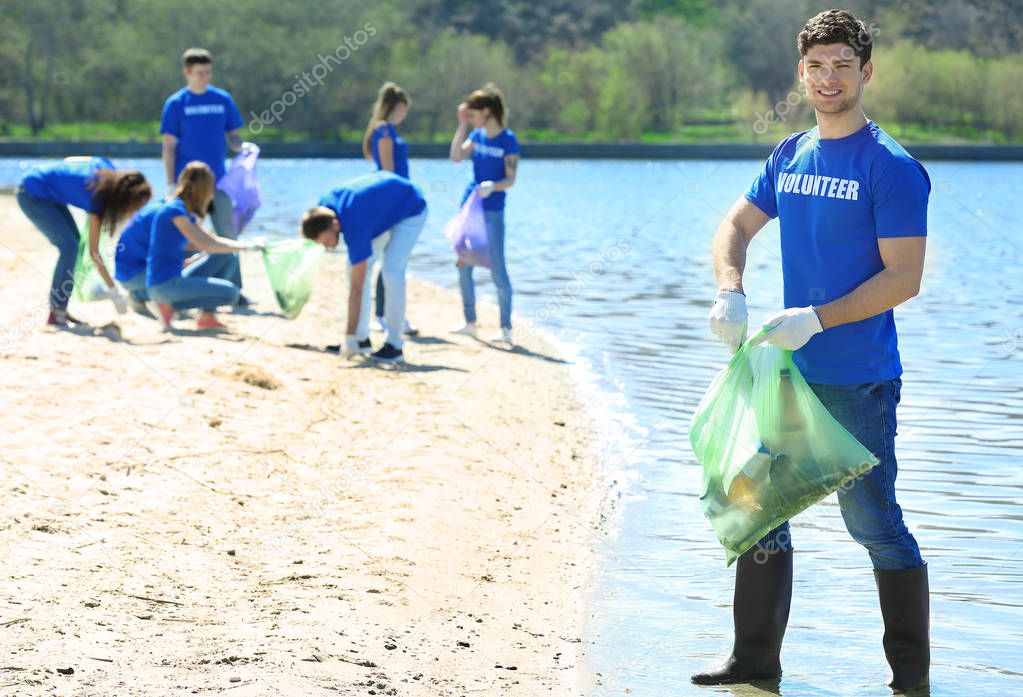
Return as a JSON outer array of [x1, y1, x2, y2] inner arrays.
[[318, 170, 427, 265]]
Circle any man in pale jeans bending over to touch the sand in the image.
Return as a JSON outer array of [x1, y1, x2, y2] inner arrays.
[[302, 170, 427, 364]]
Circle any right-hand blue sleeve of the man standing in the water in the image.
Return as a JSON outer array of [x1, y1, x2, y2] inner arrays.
[[871, 161, 931, 237]]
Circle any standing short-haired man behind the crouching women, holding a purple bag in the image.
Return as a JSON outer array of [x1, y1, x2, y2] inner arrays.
[[160, 48, 248, 298]]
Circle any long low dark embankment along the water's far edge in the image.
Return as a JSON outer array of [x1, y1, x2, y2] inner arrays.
[[0, 140, 1023, 162]]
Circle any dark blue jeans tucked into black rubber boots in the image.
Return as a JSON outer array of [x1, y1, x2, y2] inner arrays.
[[757, 378, 924, 571]]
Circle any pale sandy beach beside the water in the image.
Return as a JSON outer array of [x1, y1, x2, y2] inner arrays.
[[0, 194, 603, 697]]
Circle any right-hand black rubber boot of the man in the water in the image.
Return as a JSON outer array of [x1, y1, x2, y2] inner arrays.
[[874, 564, 931, 695]]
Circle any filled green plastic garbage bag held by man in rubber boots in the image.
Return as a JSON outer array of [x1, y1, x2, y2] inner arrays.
[[690, 333, 878, 565]]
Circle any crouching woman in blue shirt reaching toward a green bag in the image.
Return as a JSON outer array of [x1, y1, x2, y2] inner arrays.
[[145, 162, 263, 330]]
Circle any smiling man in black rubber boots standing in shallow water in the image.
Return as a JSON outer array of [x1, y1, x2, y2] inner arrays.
[[693, 10, 930, 690]]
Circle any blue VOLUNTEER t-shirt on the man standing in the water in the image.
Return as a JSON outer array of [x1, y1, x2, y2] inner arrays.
[[746, 122, 931, 385]]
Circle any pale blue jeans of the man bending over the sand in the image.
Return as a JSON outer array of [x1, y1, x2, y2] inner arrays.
[[355, 209, 427, 349]]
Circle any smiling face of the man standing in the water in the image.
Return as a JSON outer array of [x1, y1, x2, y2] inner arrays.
[[797, 44, 874, 114]]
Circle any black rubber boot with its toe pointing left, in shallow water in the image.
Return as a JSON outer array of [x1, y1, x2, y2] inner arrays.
[[692, 548, 792, 685]]
